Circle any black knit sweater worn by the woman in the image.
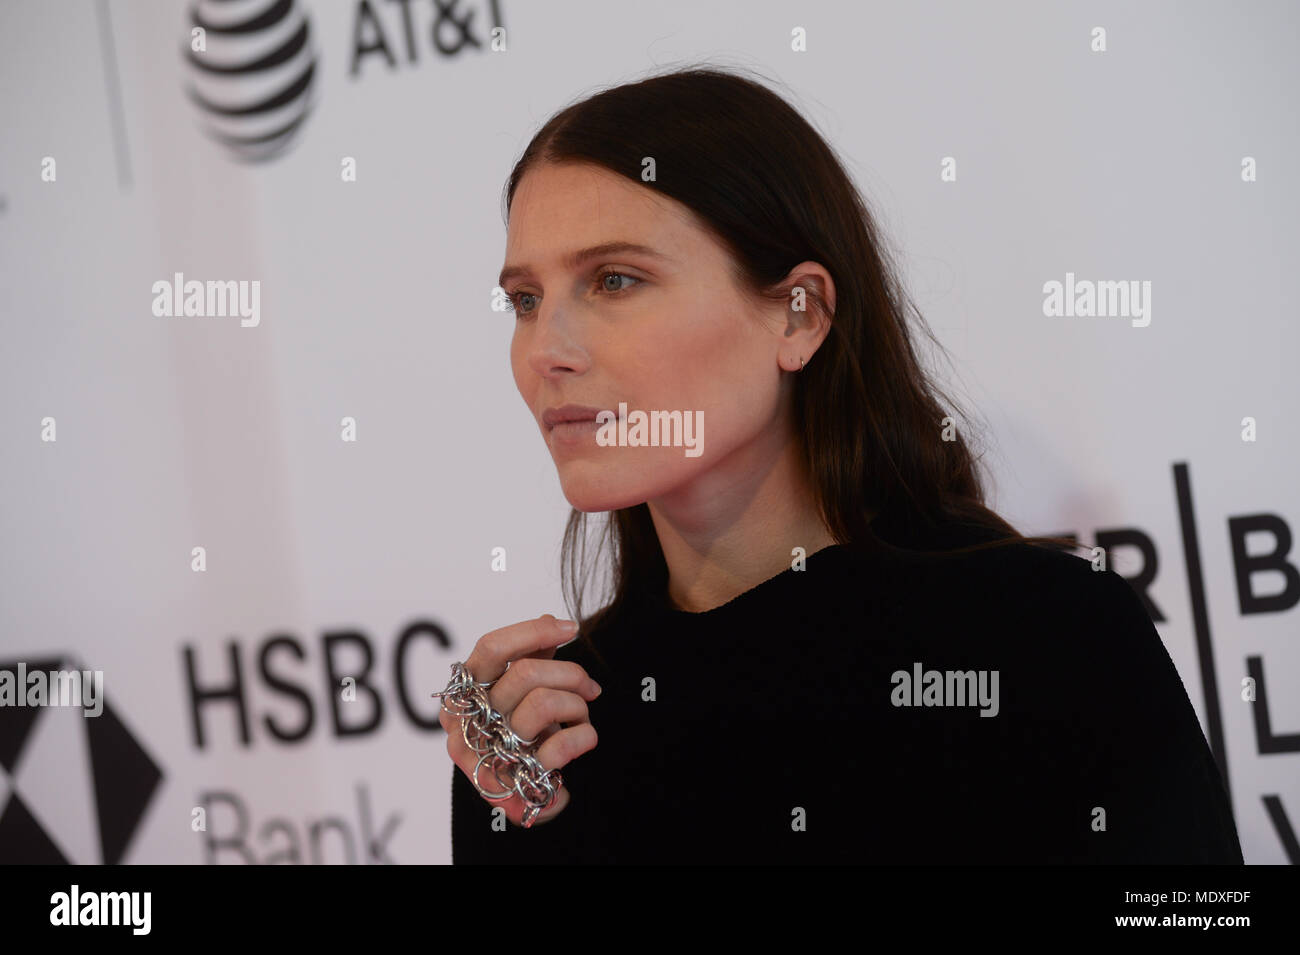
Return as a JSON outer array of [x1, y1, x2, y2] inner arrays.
[[451, 543, 1242, 864]]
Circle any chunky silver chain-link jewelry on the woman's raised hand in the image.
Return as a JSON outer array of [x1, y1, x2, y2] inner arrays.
[[433, 661, 563, 829]]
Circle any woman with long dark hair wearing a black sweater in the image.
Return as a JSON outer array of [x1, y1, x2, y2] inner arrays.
[[442, 69, 1242, 863]]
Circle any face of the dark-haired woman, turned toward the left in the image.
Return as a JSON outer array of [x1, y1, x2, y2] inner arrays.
[[501, 164, 811, 512]]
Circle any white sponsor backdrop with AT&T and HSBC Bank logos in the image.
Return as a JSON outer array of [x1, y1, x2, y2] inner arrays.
[[0, 0, 1300, 864]]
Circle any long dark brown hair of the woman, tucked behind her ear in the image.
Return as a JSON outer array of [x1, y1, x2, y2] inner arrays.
[[504, 66, 1076, 654]]
